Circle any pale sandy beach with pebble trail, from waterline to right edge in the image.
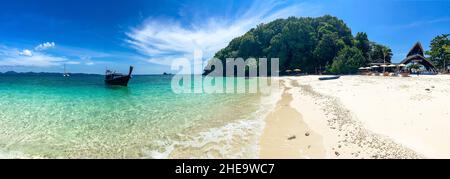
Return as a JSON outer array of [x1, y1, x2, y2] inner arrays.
[[260, 75, 450, 158]]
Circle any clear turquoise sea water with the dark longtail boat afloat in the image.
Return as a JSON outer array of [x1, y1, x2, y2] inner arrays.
[[0, 74, 274, 158]]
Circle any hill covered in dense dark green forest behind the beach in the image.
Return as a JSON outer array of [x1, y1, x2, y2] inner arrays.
[[205, 15, 392, 75]]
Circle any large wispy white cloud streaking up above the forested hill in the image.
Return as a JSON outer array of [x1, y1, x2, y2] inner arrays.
[[126, 0, 317, 68]]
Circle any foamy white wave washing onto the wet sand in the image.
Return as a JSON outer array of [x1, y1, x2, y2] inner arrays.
[[144, 83, 281, 159]]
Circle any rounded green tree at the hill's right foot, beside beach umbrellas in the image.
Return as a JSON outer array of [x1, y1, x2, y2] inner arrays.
[[330, 47, 368, 74]]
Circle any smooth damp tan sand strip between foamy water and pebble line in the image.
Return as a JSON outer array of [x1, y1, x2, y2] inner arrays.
[[260, 81, 325, 159]]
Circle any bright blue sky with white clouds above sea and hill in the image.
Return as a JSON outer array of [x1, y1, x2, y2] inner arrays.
[[0, 0, 450, 74]]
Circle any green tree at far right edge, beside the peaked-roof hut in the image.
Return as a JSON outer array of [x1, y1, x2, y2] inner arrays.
[[427, 34, 450, 70]]
